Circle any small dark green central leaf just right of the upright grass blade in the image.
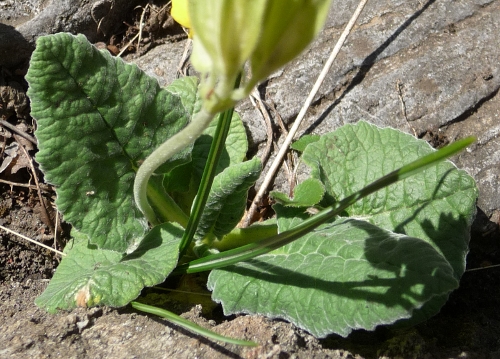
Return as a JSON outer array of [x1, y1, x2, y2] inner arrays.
[[195, 158, 262, 245]]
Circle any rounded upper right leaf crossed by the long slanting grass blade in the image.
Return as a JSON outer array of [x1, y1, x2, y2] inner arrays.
[[302, 121, 478, 278]]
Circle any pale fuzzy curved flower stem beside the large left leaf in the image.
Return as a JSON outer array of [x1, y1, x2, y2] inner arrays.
[[134, 107, 215, 225]]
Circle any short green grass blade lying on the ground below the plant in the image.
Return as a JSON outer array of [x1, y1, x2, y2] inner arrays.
[[130, 302, 258, 346]]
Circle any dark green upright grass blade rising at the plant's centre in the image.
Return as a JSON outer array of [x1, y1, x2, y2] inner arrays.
[[179, 107, 234, 258]]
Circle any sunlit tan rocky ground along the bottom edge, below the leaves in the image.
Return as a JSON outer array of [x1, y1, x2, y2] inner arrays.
[[0, 280, 350, 359]]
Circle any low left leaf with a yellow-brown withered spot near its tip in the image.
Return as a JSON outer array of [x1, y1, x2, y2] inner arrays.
[[36, 223, 182, 312]]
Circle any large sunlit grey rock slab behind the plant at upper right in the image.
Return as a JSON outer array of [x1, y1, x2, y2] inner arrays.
[[267, 0, 500, 134]]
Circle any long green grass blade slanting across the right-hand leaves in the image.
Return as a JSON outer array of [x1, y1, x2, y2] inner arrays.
[[172, 137, 475, 274]]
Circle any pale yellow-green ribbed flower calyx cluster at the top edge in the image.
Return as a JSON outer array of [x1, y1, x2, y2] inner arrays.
[[189, 0, 331, 100]]
